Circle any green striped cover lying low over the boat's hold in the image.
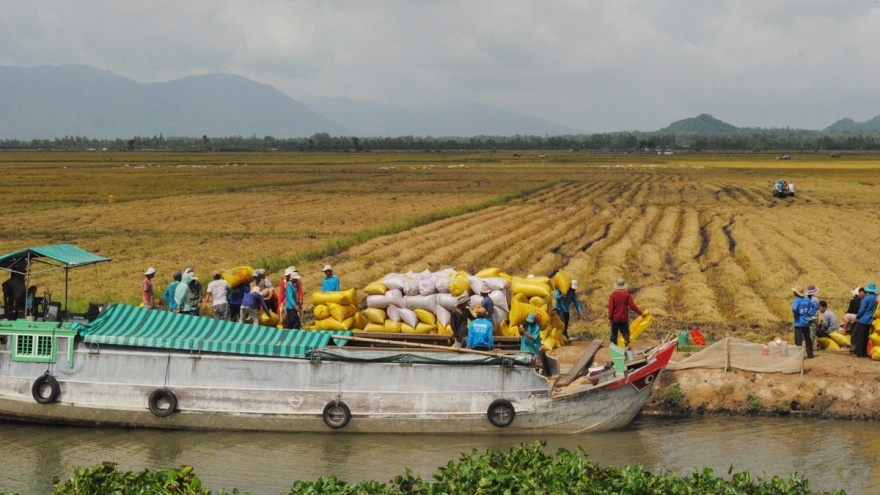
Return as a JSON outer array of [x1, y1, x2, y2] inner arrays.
[[80, 304, 351, 357]]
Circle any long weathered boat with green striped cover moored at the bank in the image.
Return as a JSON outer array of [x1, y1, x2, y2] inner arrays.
[[0, 305, 675, 434]]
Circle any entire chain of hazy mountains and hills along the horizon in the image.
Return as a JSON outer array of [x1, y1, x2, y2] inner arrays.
[[0, 65, 880, 140]]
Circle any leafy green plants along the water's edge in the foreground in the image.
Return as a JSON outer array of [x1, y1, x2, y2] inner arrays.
[[0, 442, 845, 495]]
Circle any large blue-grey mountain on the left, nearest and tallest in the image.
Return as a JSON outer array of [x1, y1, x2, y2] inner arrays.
[[0, 65, 351, 139]]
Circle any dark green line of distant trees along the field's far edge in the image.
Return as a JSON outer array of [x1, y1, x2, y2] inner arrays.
[[0, 129, 880, 152]]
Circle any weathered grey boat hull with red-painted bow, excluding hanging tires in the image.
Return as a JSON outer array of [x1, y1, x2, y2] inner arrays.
[[0, 340, 666, 435]]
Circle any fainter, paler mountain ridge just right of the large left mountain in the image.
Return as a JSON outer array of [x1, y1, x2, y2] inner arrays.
[[304, 98, 584, 137]]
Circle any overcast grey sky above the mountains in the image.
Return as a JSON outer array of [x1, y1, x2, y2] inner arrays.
[[0, 0, 880, 132]]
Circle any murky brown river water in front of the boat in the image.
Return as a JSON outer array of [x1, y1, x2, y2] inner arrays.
[[0, 417, 880, 495]]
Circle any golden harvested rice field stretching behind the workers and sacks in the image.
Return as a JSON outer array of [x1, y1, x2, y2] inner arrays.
[[0, 153, 880, 338]]
